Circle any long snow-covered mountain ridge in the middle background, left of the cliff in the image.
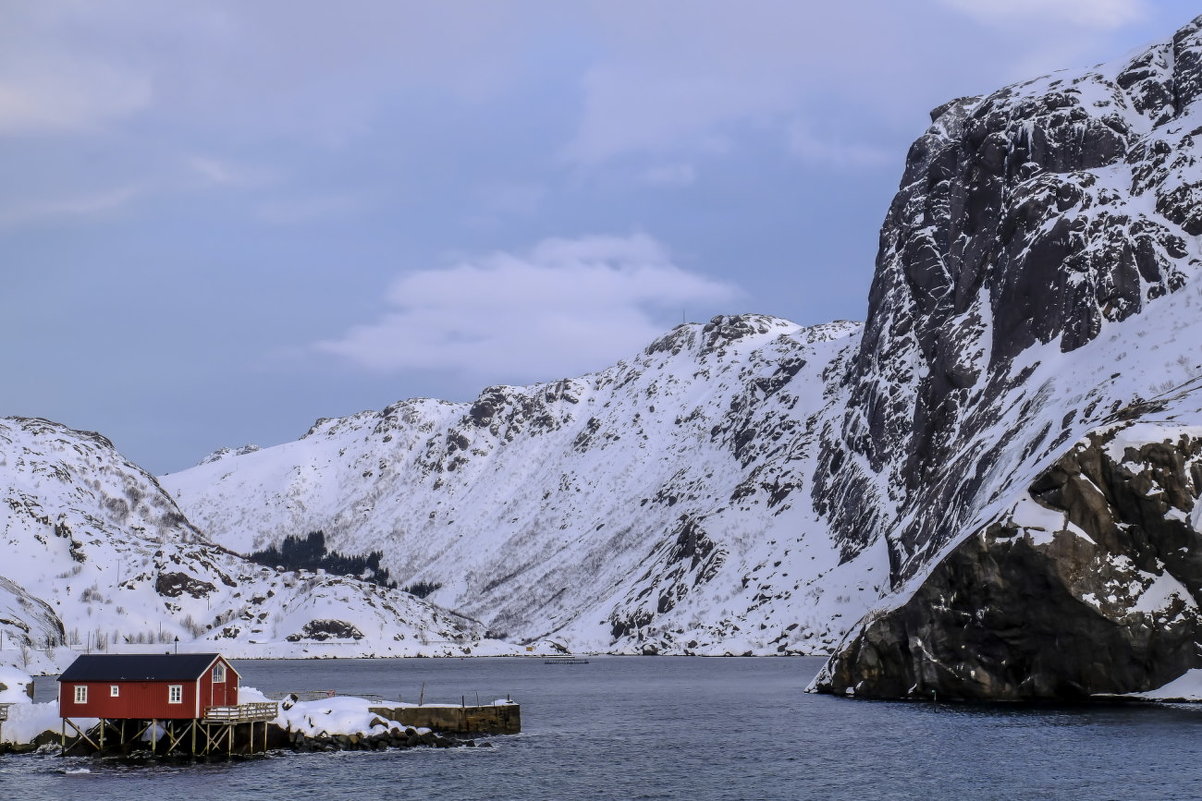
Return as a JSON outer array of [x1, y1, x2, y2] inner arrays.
[[161, 315, 887, 653]]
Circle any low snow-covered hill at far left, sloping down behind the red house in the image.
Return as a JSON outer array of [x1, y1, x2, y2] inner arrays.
[[0, 417, 495, 669]]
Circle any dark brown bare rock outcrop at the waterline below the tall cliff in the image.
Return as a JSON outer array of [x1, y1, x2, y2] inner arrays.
[[819, 423, 1202, 700]]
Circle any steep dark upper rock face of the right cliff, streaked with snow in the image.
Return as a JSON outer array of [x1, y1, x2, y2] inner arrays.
[[816, 15, 1202, 583]]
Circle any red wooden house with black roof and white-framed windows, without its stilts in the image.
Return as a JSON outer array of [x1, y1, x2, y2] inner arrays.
[[59, 653, 238, 720]]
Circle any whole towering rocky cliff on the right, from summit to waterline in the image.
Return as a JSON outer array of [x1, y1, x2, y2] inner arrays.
[[816, 18, 1202, 699]]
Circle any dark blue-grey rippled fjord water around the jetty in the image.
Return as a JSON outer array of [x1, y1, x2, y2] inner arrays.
[[0, 657, 1202, 801]]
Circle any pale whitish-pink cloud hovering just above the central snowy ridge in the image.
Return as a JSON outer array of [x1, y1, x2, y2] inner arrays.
[[314, 235, 740, 381]]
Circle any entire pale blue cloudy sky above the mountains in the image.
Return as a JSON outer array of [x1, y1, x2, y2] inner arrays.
[[0, 0, 1198, 474]]
